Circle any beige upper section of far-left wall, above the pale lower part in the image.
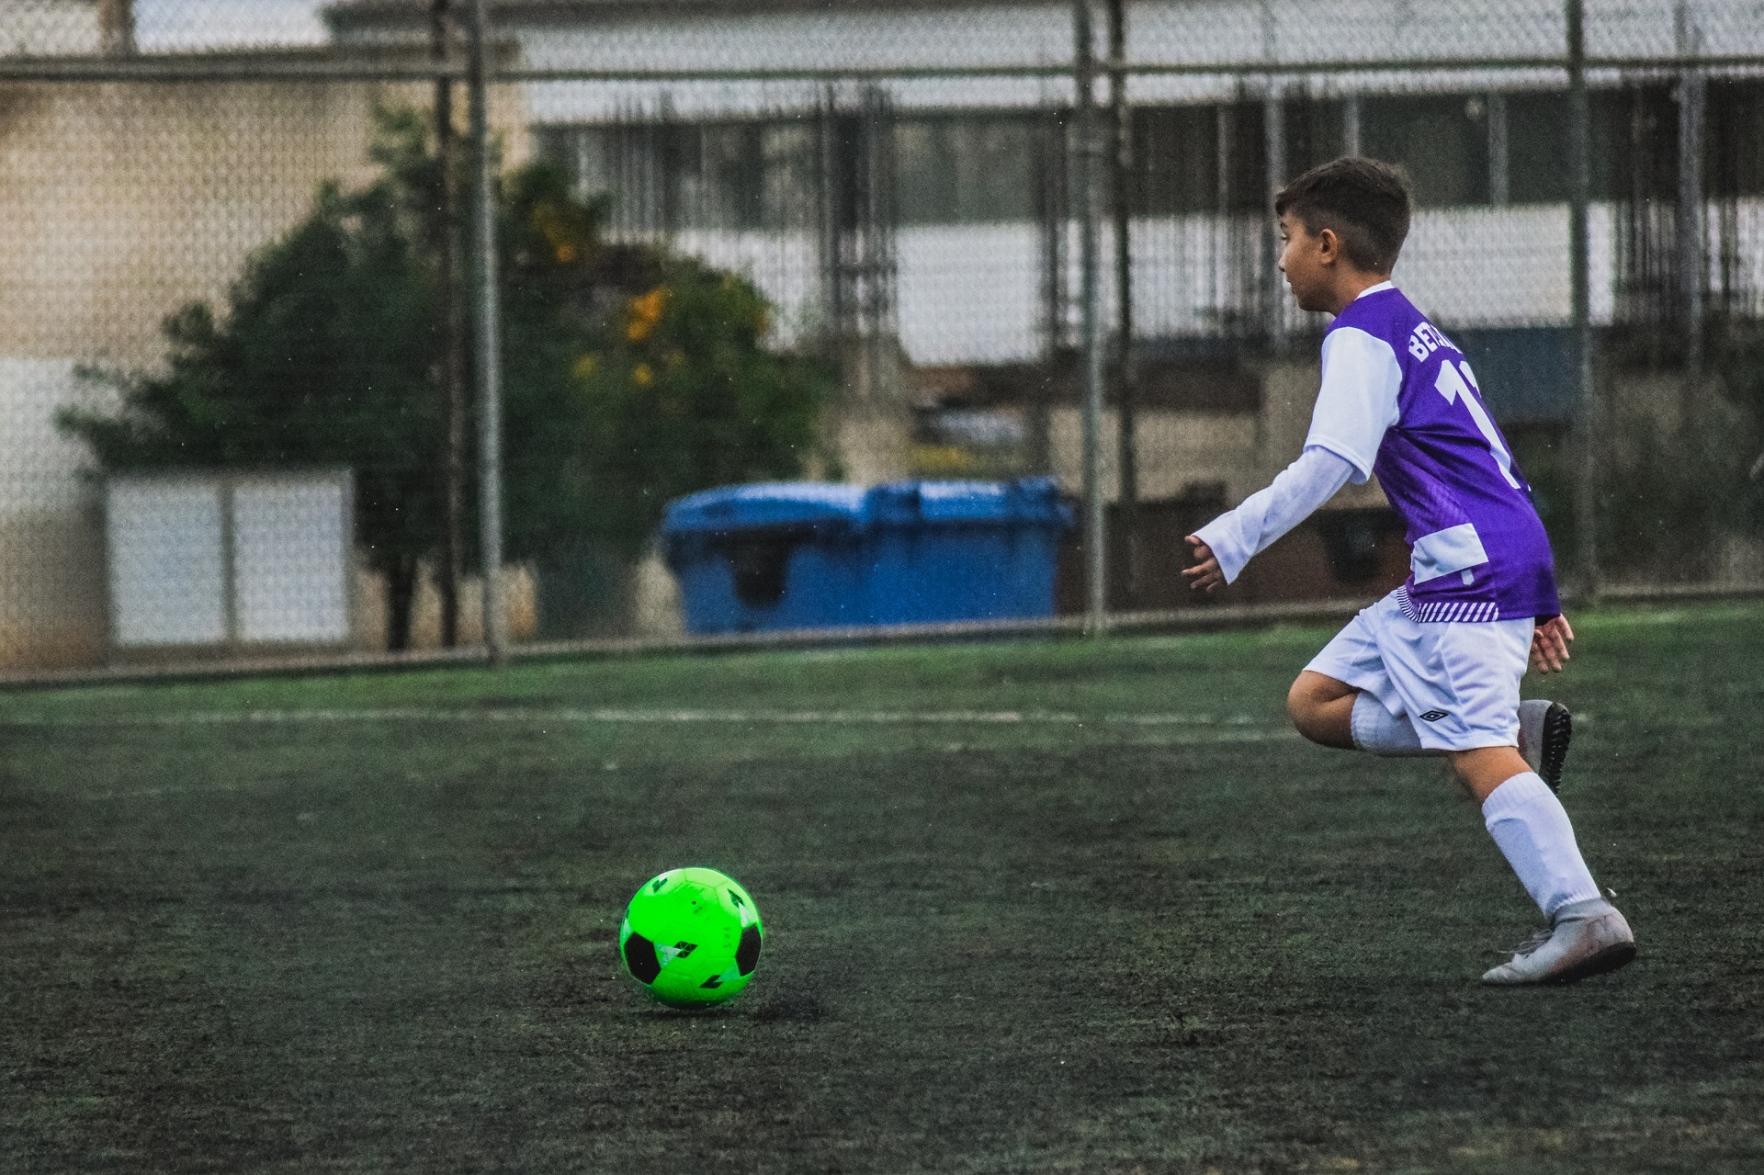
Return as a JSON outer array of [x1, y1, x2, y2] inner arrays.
[[0, 83, 444, 367]]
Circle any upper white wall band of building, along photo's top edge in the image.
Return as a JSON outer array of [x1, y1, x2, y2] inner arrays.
[[324, 0, 1764, 112]]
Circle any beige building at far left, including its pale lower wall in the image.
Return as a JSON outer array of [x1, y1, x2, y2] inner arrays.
[[0, 61, 524, 669]]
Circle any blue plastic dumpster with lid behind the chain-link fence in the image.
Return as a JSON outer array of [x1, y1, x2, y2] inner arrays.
[[662, 478, 1071, 633]]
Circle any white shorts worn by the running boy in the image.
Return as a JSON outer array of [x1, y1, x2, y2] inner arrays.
[[1305, 591, 1535, 752]]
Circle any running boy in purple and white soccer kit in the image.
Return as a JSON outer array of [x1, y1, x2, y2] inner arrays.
[[1182, 159, 1635, 984]]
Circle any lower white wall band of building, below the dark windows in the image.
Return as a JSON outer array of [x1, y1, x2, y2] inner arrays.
[[674, 201, 1651, 367]]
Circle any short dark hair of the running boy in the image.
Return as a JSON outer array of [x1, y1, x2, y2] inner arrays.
[[1274, 155, 1411, 273]]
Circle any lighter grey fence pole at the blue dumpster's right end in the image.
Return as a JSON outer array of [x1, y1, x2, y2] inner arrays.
[[1073, 0, 1108, 635]]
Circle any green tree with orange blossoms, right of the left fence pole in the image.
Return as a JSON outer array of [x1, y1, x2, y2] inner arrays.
[[503, 168, 834, 558]]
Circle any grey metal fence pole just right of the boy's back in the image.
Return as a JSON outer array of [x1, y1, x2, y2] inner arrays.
[[1566, 0, 1598, 600]]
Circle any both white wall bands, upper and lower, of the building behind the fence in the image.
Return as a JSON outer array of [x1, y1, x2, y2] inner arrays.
[[333, 0, 1764, 363]]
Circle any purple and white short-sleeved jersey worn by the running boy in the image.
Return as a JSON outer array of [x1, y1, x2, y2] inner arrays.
[[1305, 282, 1561, 621]]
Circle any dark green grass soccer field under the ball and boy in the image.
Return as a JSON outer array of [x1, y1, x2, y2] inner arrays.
[[0, 603, 1764, 1173]]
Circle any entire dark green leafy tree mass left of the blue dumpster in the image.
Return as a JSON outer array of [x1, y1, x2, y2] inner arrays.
[[62, 113, 833, 647]]
